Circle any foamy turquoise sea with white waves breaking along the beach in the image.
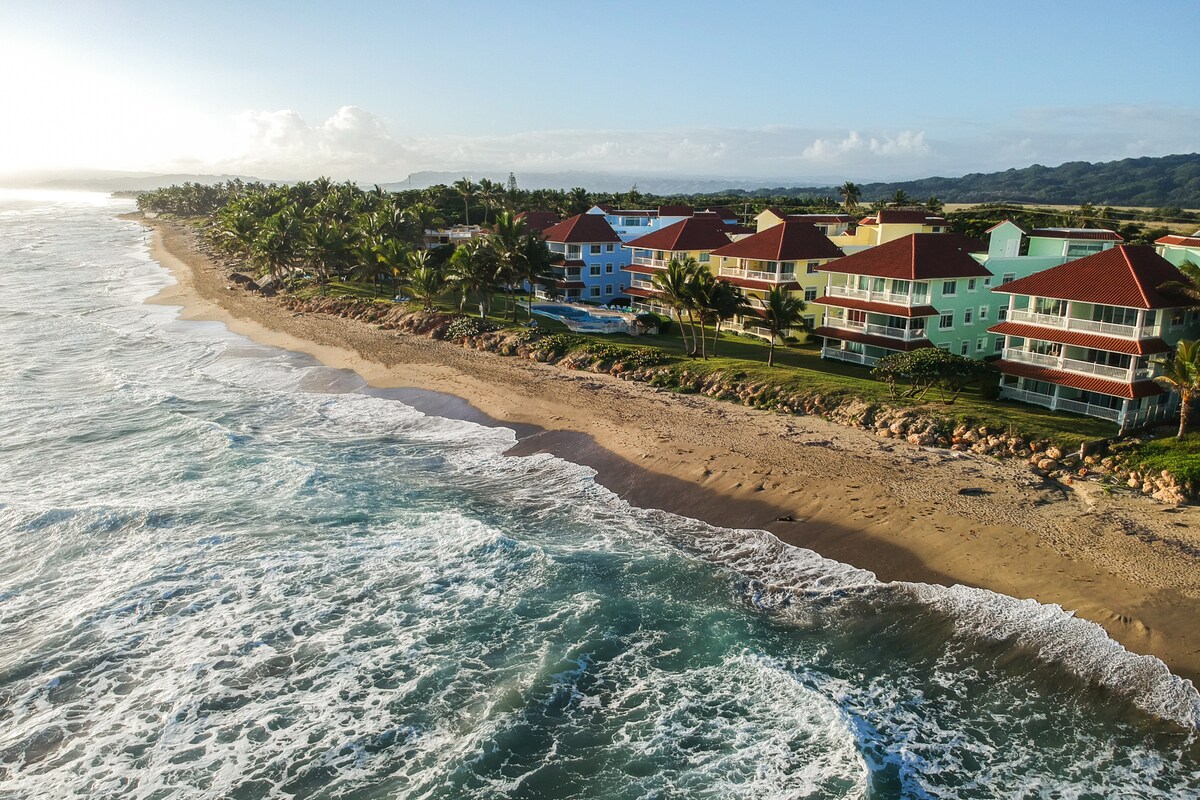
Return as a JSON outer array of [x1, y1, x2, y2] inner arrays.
[[0, 194, 1200, 799]]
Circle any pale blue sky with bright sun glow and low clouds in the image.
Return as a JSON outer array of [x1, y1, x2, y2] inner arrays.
[[0, 0, 1200, 185]]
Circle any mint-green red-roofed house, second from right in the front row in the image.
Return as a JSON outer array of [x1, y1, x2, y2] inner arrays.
[[815, 233, 1000, 366]]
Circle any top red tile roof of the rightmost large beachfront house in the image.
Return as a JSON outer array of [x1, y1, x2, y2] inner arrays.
[[993, 245, 1190, 308]]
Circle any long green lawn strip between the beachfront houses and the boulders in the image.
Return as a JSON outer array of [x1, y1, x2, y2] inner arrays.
[[298, 282, 1123, 448]]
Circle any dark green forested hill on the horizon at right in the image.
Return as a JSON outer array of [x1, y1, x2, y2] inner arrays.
[[734, 152, 1200, 209]]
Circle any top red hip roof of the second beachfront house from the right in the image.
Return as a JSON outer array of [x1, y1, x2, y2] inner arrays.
[[821, 234, 988, 280]]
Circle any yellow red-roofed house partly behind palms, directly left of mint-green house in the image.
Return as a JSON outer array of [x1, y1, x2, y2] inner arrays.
[[709, 216, 842, 339]]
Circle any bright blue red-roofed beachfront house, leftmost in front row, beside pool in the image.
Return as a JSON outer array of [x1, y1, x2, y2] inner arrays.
[[534, 213, 629, 303]]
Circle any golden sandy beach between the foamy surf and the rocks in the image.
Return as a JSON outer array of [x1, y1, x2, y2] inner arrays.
[[136, 215, 1200, 682]]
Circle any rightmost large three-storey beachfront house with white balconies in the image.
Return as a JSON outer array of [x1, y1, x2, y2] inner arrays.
[[991, 245, 1196, 431]]
